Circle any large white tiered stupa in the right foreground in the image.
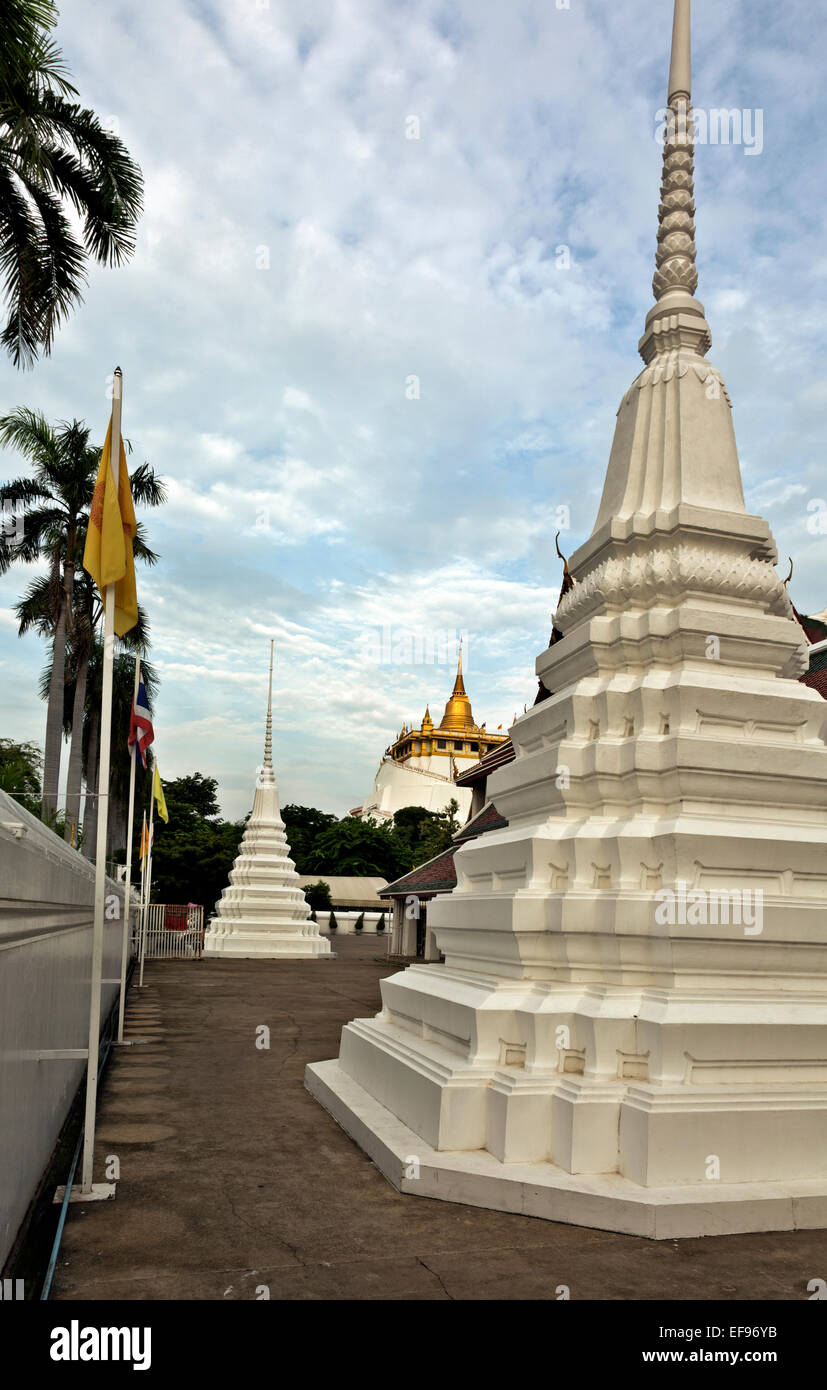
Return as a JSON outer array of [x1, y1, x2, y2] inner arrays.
[[306, 0, 827, 1238]]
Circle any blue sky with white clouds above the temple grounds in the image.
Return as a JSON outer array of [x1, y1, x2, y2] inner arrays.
[[0, 0, 827, 816]]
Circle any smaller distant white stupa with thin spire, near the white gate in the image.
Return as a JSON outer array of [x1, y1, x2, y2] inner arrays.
[[204, 642, 331, 960]]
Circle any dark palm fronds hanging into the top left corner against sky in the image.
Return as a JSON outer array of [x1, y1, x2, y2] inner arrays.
[[0, 0, 143, 367]]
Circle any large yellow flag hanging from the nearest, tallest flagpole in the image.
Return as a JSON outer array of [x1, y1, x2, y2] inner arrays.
[[83, 417, 138, 637]]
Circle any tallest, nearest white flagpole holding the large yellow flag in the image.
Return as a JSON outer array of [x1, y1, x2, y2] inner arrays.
[[82, 367, 128, 1193]]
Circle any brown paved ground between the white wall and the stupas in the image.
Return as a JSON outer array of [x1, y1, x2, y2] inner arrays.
[[53, 938, 827, 1300]]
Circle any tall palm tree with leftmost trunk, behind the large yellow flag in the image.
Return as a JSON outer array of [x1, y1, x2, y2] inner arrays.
[[0, 407, 167, 819]]
